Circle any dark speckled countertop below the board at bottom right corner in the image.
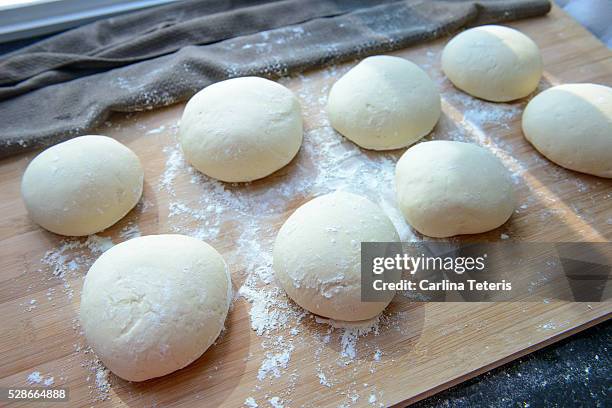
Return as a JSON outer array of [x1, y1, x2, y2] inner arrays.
[[413, 321, 612, 408]]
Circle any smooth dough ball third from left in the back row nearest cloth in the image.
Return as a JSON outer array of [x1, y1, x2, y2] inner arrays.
[[327, 55, 440, 150]]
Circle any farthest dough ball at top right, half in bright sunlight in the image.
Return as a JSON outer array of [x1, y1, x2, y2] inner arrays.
[[442, 25, 542, 102]]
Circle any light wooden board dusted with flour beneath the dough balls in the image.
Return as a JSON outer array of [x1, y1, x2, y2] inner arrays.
[[0, 3, 612, 407]]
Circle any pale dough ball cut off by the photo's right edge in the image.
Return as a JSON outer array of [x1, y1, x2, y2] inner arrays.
[[523, 84, 612, 178]]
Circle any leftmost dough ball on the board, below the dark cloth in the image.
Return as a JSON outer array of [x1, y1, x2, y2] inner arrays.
[[21, 136, 144, 236]]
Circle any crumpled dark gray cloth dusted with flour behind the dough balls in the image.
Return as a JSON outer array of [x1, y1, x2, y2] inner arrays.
[[0, 0, 550, 157]]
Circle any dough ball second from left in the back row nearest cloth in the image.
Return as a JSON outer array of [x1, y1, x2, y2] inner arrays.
[[180, 77, 302, 182]]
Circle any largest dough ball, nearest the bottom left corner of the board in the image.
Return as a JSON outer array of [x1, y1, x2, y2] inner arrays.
[[80, 235, 231, 381]]
